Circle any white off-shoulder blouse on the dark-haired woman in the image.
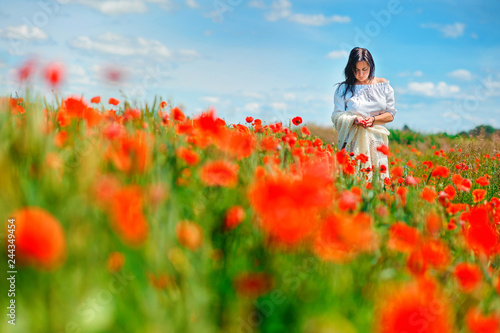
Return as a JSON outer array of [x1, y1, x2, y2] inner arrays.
[[333, 81, 397, 117]]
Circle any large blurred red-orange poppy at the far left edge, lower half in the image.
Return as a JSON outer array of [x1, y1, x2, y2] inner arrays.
[[5, 207, 66, 270]]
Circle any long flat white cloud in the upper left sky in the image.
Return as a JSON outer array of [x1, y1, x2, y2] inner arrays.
[[69, 33, 201, 61]]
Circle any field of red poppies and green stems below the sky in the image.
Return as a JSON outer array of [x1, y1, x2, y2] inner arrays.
[[0, 86, 500, 333]]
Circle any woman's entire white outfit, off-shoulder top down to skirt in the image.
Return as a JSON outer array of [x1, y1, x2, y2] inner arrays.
[[332, 81, 397, 179]]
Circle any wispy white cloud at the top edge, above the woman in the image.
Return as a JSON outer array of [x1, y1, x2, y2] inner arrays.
[[262, 0, 351, 26]]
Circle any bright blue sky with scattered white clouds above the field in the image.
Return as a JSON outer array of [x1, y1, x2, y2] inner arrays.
[[0, 0, 500, 133]]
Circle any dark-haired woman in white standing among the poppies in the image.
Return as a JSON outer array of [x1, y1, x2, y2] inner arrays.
[[332, 47, 397, 179]]
